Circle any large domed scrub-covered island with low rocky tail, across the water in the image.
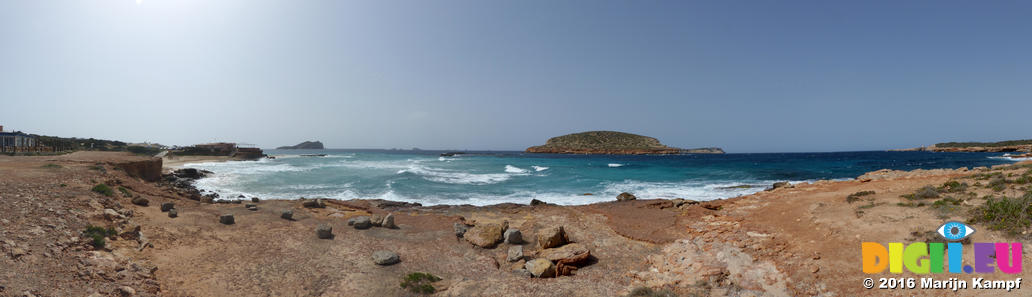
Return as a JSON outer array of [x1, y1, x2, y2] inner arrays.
[[526, 131, 723, 155]]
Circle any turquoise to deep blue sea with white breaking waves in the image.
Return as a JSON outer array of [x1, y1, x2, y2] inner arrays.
[[188, 150, 1013, 205]]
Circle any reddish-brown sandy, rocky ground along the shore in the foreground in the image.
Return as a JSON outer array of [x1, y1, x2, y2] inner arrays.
[[0, 153, 1032, 296]]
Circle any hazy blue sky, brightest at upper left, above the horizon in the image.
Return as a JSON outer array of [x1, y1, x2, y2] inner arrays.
[[0, 0, 1032, 153]]
